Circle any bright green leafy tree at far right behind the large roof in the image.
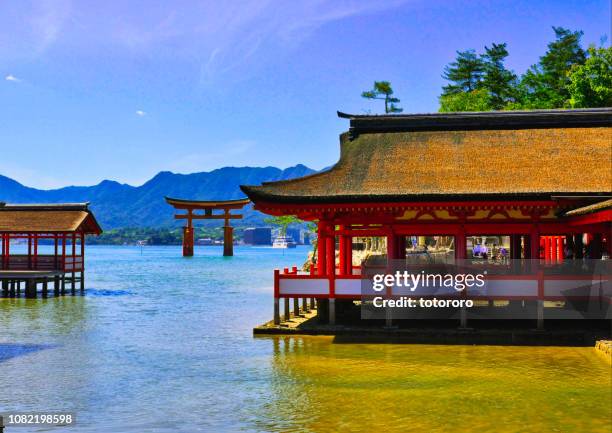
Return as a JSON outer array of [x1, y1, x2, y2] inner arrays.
[[567, 46, 612, 108]]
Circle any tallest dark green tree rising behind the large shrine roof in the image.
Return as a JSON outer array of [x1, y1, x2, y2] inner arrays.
[[519, 27, 586, 108]]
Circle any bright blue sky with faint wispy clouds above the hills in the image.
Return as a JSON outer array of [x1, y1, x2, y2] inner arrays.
[[0, 0, 610, 188]]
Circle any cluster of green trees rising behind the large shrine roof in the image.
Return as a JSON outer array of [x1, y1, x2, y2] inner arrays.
[[439, 27, 612, 112]]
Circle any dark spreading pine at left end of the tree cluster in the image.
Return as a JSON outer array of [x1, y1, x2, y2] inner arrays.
[[442, 50, 484, 96]]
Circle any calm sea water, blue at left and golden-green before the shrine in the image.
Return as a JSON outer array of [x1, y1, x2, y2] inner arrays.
[[0, 246, 612, 433]]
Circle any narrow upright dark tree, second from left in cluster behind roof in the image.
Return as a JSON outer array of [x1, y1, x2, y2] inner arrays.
[[481, 43, 517, 110]]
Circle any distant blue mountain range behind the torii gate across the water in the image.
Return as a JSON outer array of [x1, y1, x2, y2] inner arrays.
[[0, 164, 315, 229]]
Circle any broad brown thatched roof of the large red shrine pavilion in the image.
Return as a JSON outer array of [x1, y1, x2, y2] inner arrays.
[[241, 109, 612, 203]]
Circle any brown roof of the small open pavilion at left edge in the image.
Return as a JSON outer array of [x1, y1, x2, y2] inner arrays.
[[0, 203, 102, 234]]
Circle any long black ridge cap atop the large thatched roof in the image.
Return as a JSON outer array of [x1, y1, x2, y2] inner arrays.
[[338, 107, 612, 138]]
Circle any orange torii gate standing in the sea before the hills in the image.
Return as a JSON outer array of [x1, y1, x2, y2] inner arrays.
[[165, 197, 250, 257]]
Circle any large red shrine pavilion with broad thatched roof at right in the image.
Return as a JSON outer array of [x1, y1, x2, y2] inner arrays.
[[241, 108, 612, 324]]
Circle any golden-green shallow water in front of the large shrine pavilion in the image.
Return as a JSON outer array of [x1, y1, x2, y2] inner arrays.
[[257, 336, 612, 432]]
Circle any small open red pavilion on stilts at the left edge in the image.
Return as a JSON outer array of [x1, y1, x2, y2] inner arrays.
[[0, 202, 102, 297]]
